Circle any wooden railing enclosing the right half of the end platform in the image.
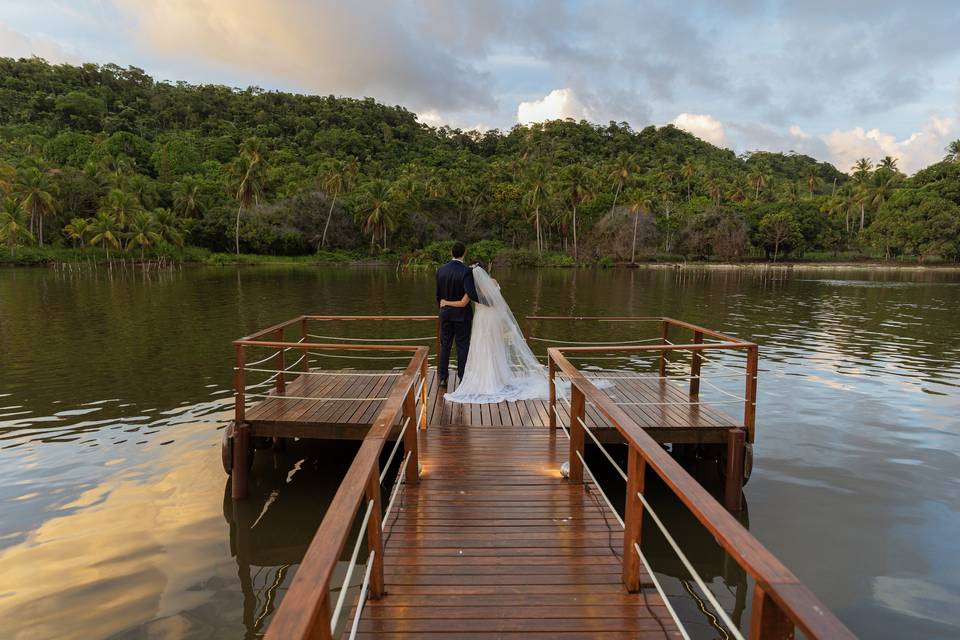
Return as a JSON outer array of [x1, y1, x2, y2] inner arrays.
[[524, 316, 759, 444]]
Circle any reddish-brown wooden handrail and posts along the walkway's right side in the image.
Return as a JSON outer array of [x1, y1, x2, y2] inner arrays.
[[547, 343, 855, 639]]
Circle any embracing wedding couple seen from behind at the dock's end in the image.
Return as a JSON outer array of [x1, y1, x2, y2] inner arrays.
[[437, 242, 549, 404]]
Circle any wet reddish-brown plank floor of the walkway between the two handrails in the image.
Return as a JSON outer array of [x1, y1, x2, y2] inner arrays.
[[354, 425, 681, 638]]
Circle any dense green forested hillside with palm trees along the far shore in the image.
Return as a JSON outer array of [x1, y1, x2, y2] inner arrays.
[[0, 58, 960, 264]]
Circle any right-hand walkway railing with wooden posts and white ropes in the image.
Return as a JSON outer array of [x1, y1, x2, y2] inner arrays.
[[547, 348, 854, 640]]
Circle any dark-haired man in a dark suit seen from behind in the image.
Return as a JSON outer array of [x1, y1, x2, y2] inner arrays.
[[437, 242, 479, 392]]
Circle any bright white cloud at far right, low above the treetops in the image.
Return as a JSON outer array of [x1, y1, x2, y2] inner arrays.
[[822, 116, 957, 174]]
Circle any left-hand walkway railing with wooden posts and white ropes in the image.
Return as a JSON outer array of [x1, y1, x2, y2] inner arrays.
[[266, 346, 428, 640]]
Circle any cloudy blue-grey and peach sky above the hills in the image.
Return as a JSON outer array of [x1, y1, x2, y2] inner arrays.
[[0, 0, 960, 172]]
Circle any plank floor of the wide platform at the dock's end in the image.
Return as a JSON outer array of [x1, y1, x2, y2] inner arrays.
[[246, 370, 743, 443]]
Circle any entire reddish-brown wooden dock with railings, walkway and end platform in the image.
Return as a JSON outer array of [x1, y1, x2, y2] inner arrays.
[[223, 316, 853, 640]]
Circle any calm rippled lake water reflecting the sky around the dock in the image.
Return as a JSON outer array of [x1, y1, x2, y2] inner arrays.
[[0, 267, 960, 639]]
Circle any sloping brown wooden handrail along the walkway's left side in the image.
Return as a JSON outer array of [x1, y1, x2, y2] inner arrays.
[[266, 345, 429, 640]]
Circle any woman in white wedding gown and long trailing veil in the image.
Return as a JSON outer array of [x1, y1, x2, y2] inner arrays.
[[440, 266, 550, 404]]
